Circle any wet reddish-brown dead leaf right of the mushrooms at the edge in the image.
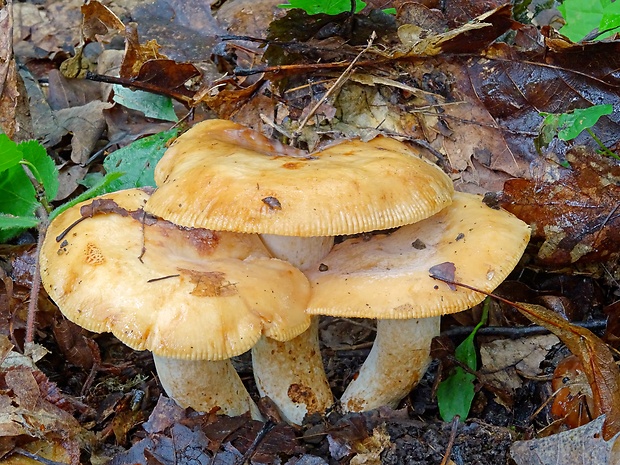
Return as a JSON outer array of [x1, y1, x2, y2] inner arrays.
[[500, 150, 620, 266]]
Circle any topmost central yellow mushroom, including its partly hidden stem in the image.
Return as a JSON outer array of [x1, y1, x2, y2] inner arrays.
[[146, 120, 453, 424]]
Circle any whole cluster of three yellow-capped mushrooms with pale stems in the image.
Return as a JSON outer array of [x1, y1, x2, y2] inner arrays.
[[41, 120, 529, 424]]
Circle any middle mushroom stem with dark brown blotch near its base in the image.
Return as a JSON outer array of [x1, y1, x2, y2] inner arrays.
[[252, 234, 334, 425]]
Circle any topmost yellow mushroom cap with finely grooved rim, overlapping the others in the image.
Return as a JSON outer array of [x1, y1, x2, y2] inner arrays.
[[146, 120, 453, 237]]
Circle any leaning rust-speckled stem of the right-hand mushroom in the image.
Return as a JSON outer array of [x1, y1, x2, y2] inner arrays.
[[340, 316, 440, 412]]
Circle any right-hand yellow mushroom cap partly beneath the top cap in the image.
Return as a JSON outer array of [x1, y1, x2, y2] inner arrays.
[[306, 192, 530, 319]]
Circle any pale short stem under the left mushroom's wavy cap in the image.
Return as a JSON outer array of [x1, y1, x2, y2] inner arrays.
[[153, 354, 262, 420]]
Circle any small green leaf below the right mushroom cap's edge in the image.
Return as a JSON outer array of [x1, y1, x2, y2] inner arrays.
[[437, 298, 489, 421]]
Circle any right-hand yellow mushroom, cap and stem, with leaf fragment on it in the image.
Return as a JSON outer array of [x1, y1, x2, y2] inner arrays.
[[306, 193, 530, 411]]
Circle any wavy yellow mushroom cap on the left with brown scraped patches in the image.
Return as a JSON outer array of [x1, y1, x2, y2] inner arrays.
[[40, 189, 310, 360]]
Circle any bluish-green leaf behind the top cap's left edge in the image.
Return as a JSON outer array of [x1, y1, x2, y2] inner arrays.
[[103, 129, 178, 192]]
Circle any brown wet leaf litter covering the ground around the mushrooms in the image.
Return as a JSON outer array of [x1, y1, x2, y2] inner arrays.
[[0, 0, 620, 465]]
